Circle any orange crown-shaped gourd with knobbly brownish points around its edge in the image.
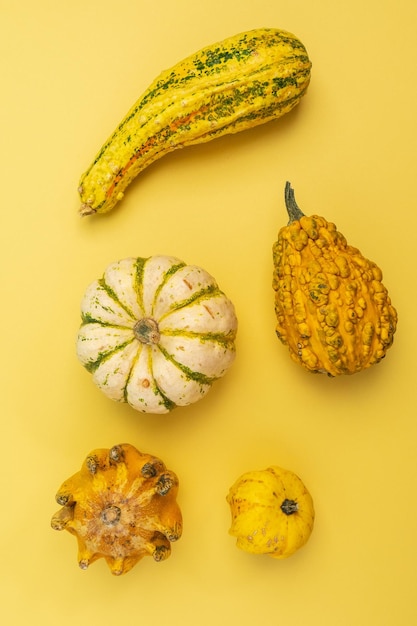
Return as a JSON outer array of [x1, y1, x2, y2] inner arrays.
[[51, 444, 182, 576]]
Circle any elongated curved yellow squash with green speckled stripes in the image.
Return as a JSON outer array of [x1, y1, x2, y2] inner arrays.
[[78, 28, 311, 216]]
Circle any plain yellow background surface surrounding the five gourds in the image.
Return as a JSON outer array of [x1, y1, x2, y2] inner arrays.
[[0, 0, 417, 626]]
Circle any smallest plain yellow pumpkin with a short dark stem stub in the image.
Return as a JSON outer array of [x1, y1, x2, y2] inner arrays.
[[226, 465, 315, 559]]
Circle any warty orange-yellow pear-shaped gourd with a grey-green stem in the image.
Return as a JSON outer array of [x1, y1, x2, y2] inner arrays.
[[273, 183, 397, 376]]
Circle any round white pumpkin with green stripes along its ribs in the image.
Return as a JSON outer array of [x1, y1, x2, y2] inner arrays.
[[77, 256, 237, 413]]
